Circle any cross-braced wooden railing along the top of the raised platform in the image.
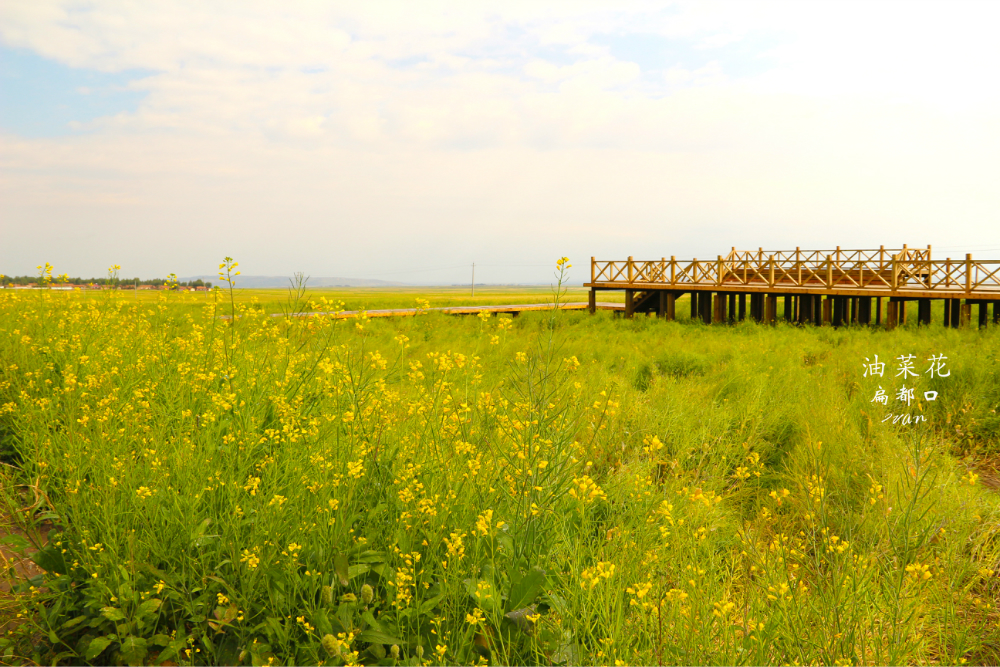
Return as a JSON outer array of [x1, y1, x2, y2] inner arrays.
[[590, 246, 1000, 296]]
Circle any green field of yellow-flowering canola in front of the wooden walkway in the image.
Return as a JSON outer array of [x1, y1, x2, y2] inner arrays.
[[0, 266, 1000, 665]]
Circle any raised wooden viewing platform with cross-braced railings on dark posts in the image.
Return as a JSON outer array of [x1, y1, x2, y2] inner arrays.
[[584, 245, 1000, 329]]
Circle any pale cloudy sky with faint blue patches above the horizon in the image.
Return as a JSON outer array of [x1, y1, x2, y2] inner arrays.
[[0, 0, 1000, 284]]
